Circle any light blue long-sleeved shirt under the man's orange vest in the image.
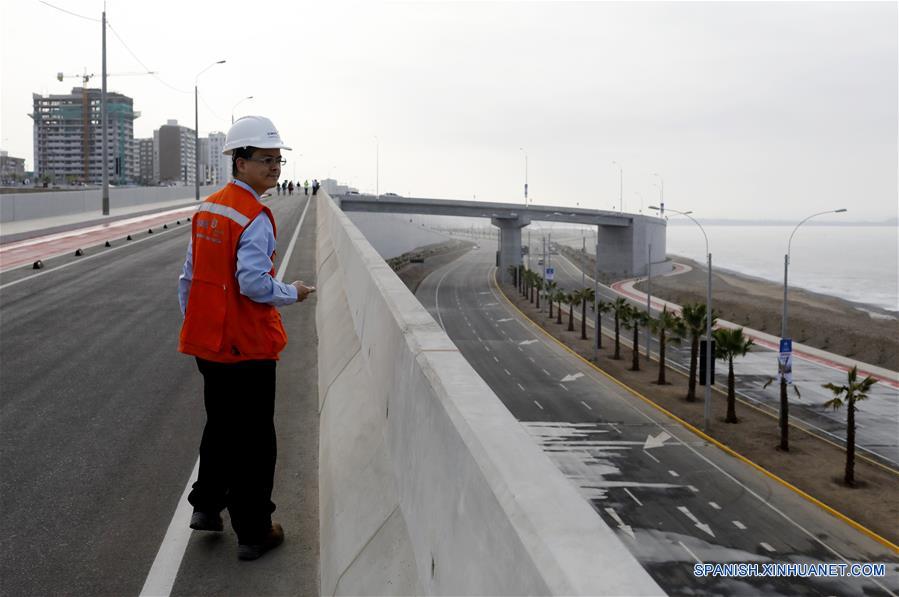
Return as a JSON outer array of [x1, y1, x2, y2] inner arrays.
[[178, 180, 297, 315]]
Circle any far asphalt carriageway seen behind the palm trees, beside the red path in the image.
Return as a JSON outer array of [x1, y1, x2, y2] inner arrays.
[[532, 233, 899, 470]]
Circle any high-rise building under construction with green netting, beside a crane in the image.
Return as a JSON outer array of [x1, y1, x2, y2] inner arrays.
[[31, 87, 140, 184]]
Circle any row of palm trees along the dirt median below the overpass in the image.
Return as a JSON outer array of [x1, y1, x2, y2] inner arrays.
[[509, 266, 877, 485]]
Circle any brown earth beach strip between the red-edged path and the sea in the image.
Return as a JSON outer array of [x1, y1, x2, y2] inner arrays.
[[636, 255, 899, 371]]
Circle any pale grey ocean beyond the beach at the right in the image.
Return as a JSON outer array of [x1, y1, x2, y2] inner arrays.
[[668, 224, 899, 312]]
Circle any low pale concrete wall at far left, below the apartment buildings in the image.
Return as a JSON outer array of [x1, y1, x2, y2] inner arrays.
[[0, 186, 219, 222]]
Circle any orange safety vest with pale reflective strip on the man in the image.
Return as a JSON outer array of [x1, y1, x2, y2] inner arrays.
[[178, 184, 287, 363]]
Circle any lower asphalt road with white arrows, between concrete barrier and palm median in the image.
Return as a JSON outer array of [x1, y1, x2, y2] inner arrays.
[[416, 242, 899, 595]]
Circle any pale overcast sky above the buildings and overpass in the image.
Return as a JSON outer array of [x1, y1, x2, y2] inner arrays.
[[0, 0, 899, 220]]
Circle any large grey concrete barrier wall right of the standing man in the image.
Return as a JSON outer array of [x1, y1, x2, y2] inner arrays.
[[316, 192, 663, 595]]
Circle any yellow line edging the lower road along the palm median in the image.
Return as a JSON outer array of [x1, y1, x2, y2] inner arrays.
[[493, 269, 899, 554]]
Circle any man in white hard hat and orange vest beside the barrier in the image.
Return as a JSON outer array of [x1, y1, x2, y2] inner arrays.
[[178, 116, 315, 560]]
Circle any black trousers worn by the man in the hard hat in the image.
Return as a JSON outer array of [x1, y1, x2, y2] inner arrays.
[[187, 358, 277, 543]]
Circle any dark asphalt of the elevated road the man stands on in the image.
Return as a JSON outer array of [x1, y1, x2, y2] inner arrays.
[[0, 197, 318, 596]]
